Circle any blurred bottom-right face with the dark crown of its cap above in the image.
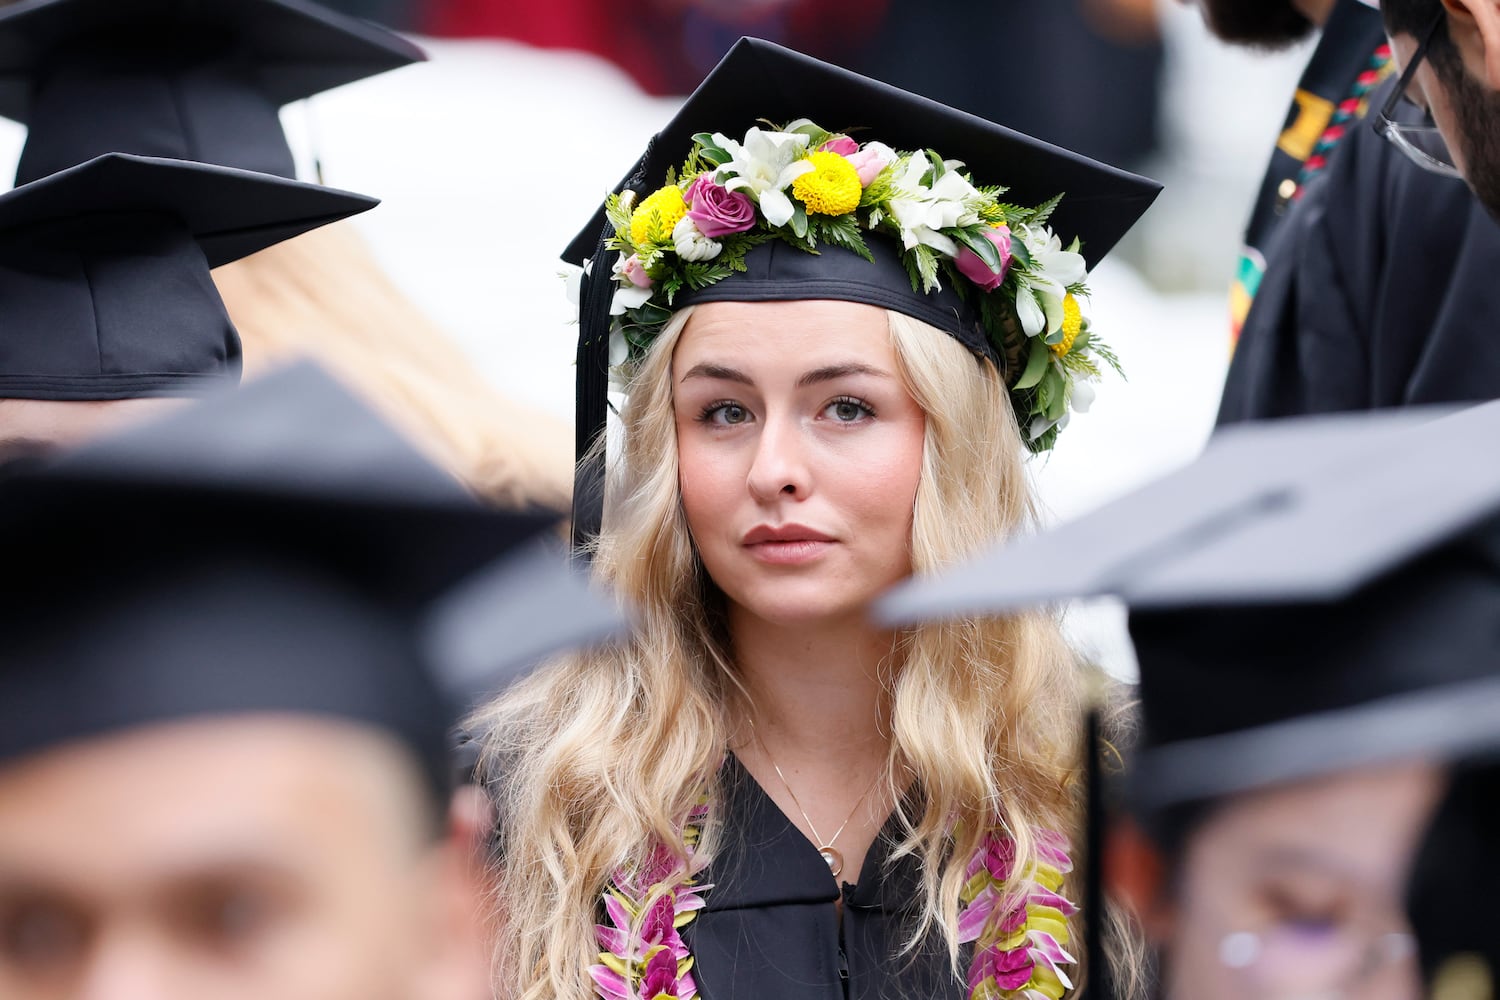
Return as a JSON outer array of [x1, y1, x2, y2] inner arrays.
[[1119, 515, 1500, 1000]]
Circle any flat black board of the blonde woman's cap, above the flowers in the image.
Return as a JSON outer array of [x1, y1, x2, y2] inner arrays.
[[563, 37, 1161, 267]]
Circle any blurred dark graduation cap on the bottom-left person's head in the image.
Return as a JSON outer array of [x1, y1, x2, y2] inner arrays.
[[0, 366, 621, 789]]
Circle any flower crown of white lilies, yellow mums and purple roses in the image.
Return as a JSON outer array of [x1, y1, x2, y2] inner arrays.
[[606, 118, 1121, 451]]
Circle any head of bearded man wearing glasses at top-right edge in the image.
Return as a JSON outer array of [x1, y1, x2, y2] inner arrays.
[[1380, 0, 1500, 216]]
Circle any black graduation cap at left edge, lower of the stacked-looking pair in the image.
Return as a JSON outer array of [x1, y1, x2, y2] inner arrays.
[[0, 153, 378, 400]]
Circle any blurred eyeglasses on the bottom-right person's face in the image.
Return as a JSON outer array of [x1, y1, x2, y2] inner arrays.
[[1220, 927, 1416, 1000]]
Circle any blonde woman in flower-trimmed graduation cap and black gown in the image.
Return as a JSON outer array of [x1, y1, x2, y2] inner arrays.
[[476, 42, 1155, 1000]]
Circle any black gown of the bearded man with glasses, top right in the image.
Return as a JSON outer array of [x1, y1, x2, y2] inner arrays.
[[1218, 72, 1500, 426]]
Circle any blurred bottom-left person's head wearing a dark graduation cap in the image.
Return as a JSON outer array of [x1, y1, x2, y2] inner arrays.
[[0, 366, 612, 1000]]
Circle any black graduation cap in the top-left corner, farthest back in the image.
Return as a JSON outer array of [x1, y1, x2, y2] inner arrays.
[[0, 0, 426, 184]]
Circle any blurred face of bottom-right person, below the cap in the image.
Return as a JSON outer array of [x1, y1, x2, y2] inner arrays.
[[1118, 763, 1445, 1000]]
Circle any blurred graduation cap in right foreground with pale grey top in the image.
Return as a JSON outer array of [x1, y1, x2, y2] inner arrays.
[[879, 403, 1500, 810]]
